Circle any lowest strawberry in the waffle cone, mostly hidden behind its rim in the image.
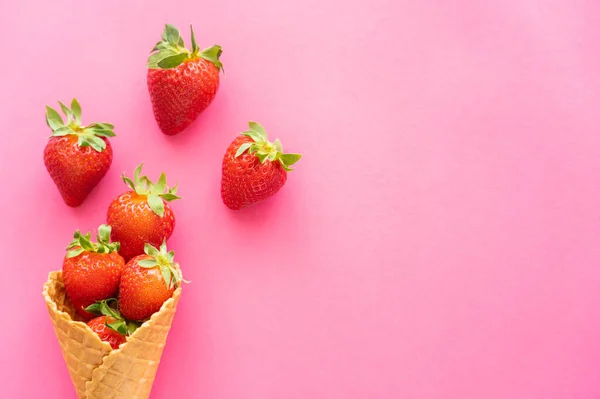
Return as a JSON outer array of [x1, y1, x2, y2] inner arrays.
[[85, 298, 138, 349]]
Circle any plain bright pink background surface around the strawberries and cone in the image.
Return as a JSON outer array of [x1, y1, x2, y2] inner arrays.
[[0, 0, 600, 399]]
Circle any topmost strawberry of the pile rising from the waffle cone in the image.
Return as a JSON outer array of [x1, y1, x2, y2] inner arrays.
[[107, 165, 180, 260]]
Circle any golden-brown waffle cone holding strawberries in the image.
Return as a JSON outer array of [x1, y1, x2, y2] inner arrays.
[[43, 271, 181, 399]]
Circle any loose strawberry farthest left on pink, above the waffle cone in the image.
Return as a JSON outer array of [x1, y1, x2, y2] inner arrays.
[[44, 99, 115, 207]]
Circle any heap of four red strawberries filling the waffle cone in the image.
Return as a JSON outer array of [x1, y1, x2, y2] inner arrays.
[[62, 165, 184, 349]]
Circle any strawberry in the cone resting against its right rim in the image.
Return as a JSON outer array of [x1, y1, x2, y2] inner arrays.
[[119, 242, 183, 321]]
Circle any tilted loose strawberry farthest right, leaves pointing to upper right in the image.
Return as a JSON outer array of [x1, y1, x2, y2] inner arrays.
[[221, 122, 301, 210]]
